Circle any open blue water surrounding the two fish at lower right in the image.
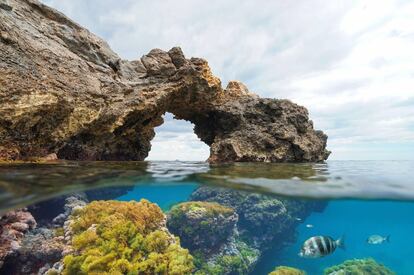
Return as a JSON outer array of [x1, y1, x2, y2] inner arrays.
[[257, 200, 414, 275]]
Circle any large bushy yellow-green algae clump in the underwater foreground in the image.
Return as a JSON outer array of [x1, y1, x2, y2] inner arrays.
[[63, 200, 194, 275]]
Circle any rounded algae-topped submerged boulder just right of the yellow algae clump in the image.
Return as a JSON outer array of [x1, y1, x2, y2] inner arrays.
[[167, 201, 259, 275]]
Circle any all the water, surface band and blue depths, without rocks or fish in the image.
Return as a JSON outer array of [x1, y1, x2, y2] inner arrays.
[[0, 161, 414, 275]]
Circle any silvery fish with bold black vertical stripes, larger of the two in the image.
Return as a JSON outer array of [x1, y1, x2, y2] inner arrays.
[[299, 236, 345, 258]]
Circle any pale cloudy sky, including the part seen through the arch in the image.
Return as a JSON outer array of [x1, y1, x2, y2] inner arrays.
[[42, 0, 414, 160]]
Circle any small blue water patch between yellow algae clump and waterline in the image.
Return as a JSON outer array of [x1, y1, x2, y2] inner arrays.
[[117, 183, 198, 211]]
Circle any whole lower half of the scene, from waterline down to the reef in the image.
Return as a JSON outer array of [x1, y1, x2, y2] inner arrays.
[[0, 161, 414, 275]]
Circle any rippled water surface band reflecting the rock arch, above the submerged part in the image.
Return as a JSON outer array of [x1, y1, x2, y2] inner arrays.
[[0, 161, 414, 213]]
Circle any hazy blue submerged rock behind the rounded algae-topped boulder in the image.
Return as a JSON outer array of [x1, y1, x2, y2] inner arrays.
[[190, 187, 326, 252]]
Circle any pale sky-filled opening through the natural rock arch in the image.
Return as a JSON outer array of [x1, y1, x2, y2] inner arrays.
[[145, 112, 210, 161]]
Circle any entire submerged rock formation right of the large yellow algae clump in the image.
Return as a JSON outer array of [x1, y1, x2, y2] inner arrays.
[[180, 186, 326, 274]]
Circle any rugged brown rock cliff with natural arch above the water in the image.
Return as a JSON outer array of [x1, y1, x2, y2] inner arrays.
[[0, 0, 329, 162]]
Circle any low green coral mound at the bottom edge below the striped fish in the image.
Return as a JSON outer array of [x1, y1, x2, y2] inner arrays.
[[324, 258, 396, 275]]
